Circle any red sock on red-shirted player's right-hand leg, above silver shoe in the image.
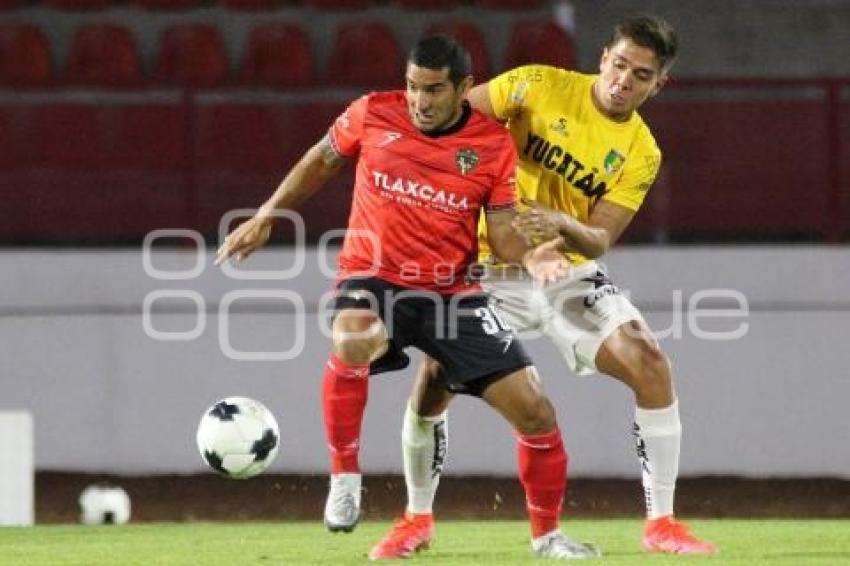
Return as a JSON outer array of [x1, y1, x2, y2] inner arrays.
[[517, 427, 567, 538]]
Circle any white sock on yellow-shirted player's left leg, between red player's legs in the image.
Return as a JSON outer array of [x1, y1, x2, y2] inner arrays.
[[401, 403, 449, 514]]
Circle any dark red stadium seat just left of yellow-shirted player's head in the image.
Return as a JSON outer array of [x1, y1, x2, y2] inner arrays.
[[505, 22, 576, 69]]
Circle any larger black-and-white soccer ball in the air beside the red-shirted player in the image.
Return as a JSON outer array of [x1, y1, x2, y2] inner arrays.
[[197, 397, 280, 479]]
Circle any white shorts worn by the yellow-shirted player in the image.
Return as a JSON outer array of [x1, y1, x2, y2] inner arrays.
[[482, 261, 643, 375]]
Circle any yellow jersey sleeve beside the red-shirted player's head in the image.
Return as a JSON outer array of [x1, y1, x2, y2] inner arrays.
[[487, 65, 557, 121]]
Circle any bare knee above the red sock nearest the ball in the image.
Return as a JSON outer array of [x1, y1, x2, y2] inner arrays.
[[333, 309, 387, 364]]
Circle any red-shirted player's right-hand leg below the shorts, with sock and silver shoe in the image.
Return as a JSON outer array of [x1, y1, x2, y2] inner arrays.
[[481, 366, 599, 558]]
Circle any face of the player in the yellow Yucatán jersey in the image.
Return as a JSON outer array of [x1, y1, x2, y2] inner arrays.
[[593, 38, 667, 120]]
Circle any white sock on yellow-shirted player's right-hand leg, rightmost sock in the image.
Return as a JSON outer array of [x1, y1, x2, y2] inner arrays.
[[634, 400, 682, 519]]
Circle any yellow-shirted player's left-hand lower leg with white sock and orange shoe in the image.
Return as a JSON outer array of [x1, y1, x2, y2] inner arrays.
[[369, 358, 454, 560]]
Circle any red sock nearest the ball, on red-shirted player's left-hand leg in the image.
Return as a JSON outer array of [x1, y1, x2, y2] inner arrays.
[[322, 354, 369, 474]]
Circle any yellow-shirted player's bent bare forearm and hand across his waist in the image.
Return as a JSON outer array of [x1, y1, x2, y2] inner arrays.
[[513, 199, 635, 259]]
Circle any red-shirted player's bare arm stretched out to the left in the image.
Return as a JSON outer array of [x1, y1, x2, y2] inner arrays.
[[215, 136, 345, 265]]
